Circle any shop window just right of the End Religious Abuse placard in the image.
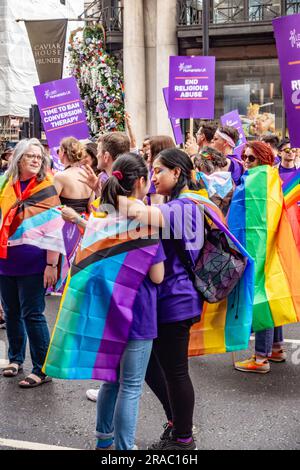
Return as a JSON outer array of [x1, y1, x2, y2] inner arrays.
[[215, 59, 282, 138]]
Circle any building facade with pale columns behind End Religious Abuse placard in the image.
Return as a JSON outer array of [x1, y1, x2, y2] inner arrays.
[[83, 0, 300, 142]]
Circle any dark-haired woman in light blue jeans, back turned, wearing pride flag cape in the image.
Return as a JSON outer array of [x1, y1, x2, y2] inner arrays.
[[90, 153, 165, 450]]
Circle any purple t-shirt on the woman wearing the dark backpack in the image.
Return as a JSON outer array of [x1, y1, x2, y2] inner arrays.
[[157, 199, 204, 323]]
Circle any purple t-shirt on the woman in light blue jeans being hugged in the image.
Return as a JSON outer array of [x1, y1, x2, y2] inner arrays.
[[129, 242, 166, 340]]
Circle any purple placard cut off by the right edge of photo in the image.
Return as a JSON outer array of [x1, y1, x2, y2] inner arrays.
[[273, 15, 300, 147]]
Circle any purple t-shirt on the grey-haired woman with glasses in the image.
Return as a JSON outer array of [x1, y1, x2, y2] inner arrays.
[[0, 179, 47, 276]]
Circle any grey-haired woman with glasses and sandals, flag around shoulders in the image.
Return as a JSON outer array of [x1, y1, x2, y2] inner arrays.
[[0, 139, 60, 388]]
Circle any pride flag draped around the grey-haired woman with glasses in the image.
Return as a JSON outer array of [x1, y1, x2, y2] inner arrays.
[[0, 174, 81, 280]]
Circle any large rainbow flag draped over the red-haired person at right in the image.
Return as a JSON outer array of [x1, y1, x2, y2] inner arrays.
[[228, 165, 300, 332]]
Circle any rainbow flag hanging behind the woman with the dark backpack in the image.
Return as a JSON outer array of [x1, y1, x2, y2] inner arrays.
[[180, 191, 254, 356]]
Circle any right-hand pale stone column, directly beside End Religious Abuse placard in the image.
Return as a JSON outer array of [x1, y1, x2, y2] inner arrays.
[[144, 0, 178, 137]]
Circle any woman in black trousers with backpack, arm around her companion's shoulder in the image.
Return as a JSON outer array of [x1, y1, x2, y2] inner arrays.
[[120, 148, 204, 450]]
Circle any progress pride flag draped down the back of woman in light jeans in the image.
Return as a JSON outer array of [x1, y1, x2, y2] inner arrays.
[[43, 213, 158, 382]]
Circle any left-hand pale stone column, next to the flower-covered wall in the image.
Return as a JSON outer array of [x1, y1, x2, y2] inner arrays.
[[123, 0, 146, 145]]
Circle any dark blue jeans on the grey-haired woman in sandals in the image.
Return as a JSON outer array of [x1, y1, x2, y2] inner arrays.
[[0, 274, 50, 376]]
